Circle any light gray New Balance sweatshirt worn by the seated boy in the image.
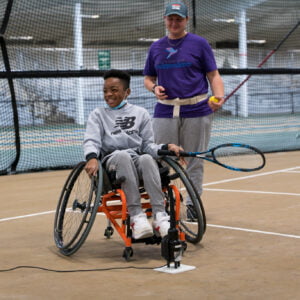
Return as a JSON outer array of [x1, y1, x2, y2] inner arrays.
[[83, 103, 163, 160]]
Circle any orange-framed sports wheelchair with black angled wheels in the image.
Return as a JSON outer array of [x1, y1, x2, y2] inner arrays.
[[54, 156, 206, 264]]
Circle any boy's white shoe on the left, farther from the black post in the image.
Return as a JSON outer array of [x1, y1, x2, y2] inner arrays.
[[130, 213, 153, 240]]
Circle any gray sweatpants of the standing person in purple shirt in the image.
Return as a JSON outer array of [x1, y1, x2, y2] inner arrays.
[[153, 114, 213, 195]]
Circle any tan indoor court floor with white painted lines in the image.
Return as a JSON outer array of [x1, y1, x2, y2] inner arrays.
[[0, 151, 300, 299]]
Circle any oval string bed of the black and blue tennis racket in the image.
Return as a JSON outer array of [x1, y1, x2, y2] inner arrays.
[[213, 146, 264, 170]]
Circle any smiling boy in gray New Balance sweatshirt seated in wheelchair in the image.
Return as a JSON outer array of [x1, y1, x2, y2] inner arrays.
[[83, 70, 184, 239]]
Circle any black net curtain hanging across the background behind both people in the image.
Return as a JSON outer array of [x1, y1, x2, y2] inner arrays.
[[0, 0, 300, 174]]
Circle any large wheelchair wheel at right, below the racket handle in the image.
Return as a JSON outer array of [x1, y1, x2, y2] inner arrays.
[[162, 156, 206, 244]]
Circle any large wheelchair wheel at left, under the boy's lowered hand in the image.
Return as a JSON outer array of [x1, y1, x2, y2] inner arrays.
[[54, 162, 103, 255]]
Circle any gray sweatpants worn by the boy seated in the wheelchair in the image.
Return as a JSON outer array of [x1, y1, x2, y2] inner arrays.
[[106, 150, 165, 217]]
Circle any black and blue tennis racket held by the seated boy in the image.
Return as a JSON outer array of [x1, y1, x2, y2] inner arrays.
[[157, 143, 266, 172]]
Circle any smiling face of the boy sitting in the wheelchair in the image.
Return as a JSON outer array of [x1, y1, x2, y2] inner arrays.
[[103, 77, 130, 107]]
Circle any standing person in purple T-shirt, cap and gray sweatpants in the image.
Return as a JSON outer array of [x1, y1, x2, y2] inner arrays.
[[144, 1, 224, 202]]
